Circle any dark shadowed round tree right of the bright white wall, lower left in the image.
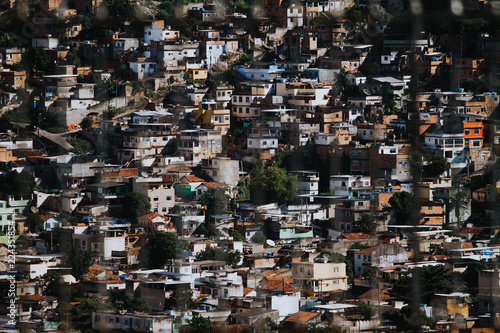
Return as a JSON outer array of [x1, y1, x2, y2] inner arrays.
[[139, 230, 185, 268]]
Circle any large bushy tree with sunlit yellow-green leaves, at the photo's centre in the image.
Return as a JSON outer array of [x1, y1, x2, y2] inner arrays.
[[251, 166, 298, 204]]
